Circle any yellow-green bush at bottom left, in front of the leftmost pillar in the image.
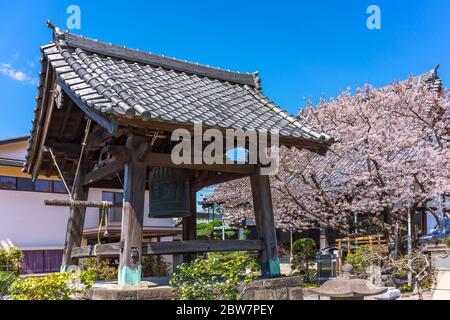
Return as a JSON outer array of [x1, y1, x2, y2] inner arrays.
[[10, 270, 95, 300]]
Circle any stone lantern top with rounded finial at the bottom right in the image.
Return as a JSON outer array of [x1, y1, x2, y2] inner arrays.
[[311, 264, 388, 300]]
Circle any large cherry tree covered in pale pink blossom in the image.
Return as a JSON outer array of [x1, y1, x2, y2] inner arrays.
[[209, 78, 450, 245]]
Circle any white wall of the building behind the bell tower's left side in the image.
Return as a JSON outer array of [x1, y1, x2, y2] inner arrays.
[[0, 141, 173, 250]]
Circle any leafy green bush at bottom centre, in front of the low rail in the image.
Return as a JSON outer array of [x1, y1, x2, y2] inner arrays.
[[169, 254, 259, 300]]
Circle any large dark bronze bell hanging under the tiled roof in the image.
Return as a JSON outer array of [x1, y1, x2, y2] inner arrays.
[[148, 168, 191, 218]]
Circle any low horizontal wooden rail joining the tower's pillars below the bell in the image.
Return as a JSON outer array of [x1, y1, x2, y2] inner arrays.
[[72, 240, 264, 258]]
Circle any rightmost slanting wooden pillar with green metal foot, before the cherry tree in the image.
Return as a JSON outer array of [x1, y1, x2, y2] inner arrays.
[[250, 168, 280, 277]]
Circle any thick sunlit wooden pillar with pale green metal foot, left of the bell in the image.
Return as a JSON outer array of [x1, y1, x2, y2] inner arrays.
[[118, 134, 146, 285]]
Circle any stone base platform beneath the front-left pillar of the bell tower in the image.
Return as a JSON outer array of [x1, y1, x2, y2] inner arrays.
[[85, 277, 172, 300]]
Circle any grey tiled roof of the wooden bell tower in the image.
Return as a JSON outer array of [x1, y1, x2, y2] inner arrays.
[[36, 28, 333, 147]]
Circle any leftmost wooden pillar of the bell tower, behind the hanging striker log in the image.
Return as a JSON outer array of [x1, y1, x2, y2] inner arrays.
[[61, 171, 89, 272]]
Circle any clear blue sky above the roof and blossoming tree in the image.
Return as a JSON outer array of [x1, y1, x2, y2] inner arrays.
[[0, 0, 450, 139]]
